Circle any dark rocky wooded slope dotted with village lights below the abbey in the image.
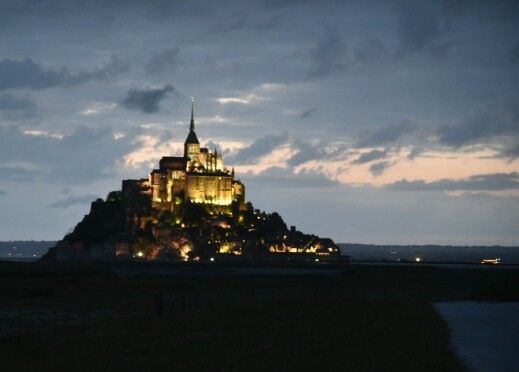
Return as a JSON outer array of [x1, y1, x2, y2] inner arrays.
[[42, 191, 340, 261]]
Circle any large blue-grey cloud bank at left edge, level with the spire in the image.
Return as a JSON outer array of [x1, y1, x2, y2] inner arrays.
[[0, 126, 134, 184]]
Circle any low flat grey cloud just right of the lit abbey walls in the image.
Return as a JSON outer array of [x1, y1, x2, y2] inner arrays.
[[244, 167, 338, 189]]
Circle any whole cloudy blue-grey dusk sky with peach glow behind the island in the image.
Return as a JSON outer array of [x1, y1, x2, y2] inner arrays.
[[0, 0, 519, 245]]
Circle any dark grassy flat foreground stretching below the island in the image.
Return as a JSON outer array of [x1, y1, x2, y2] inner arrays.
[[0, 263, 519, 371]]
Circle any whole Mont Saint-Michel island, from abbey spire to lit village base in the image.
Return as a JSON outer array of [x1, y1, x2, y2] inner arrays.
[[43, 104, 340, 261]]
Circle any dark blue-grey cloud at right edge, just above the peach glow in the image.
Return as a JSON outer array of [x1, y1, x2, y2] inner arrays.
[[437, 108, 519, 147]]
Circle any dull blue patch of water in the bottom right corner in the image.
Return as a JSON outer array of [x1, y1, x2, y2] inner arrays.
[[436, 301, 519, 371]]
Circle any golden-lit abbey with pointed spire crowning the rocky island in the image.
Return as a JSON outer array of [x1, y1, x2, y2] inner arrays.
[[127, 102, 245, 211]]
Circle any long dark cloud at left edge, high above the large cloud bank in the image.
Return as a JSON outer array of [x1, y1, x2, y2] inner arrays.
[[0, 56, 129, 90]]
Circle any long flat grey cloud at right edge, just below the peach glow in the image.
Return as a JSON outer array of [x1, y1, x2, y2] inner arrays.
[[386, 172, 519, 191]]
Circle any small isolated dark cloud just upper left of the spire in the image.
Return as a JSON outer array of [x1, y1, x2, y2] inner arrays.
[[121, 84, 176, 114]]
